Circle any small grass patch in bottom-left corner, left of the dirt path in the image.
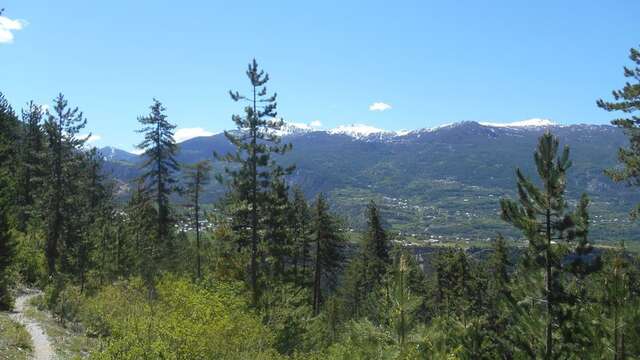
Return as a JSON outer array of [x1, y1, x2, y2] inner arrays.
[[0, 313, 32, 360]]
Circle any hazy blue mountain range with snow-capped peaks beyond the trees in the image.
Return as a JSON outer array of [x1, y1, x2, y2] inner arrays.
[[100, 119, 640, 241]]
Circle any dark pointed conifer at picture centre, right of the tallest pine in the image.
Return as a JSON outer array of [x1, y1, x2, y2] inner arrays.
[[313, 194, 344, 315]]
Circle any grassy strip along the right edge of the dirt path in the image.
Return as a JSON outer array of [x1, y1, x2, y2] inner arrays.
[[25, 296, 97, 359]]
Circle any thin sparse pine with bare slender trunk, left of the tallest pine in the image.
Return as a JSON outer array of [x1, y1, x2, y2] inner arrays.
[[186, 160, 211, 279]]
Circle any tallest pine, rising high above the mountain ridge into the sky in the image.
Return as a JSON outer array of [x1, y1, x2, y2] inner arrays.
[[215, 59, 291, 306]]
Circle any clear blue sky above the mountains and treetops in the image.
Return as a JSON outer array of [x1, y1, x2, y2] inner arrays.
[[0, 0, 640, 150]]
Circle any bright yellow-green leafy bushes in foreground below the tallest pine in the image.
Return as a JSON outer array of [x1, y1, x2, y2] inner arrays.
[[87, 277, 279, 359]]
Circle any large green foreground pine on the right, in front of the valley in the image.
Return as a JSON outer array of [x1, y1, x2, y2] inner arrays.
[[500, 132, 592, 359]]
